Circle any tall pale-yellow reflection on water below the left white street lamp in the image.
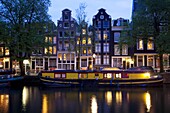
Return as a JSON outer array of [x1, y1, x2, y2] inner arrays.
[[22, 87, 29, 107]]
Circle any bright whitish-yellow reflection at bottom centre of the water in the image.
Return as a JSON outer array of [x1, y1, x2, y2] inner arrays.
[[91, 95, 98, 113]]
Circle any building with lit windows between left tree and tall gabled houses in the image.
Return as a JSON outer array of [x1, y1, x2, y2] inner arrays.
[[29, 21, 57, 73]]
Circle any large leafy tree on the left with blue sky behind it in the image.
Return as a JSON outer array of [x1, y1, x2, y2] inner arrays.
[[0, 0, 50, 75]]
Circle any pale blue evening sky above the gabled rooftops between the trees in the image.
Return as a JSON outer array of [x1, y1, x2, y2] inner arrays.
[[49, 0, 132, 23]]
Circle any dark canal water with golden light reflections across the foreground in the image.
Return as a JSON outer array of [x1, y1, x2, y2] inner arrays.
[[0, 85, 170, 113]]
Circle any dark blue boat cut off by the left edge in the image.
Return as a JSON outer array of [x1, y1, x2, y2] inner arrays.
[[0, 69, 24, 88]]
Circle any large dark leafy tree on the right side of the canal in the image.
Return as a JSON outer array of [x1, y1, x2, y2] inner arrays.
[[132, 0, 170, 72]]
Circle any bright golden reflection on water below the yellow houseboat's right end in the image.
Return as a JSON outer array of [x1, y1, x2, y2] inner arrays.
[[144, 92, 152, 112]]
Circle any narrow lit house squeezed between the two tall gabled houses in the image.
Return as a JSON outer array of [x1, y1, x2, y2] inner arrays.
[[76, 21, 93, 70]]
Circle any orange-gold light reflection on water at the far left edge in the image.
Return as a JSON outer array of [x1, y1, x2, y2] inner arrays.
[[0, 94, 9, 113]]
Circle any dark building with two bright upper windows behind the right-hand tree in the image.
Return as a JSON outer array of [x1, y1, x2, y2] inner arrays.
[[132, 0, 170, 71]]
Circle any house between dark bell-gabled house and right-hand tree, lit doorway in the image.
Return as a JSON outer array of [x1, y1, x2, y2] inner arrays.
[[111, 18, 133, 69]]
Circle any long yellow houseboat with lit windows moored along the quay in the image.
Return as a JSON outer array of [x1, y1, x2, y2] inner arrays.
[[40, 67, 163, 87]]
